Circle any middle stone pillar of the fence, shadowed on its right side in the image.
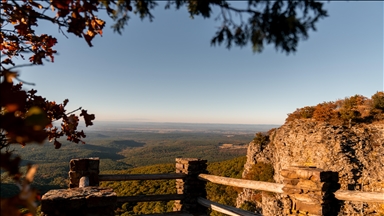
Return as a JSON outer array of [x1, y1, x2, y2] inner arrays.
[[173, 158, 207, 215]]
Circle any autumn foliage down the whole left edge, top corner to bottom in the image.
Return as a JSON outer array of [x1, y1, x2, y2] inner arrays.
[[0, 0, 99, 215]]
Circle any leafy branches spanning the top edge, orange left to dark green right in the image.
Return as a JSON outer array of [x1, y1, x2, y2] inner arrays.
[[0, 0, 327, 69]]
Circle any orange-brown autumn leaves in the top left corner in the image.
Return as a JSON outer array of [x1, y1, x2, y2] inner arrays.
[[0, 0, 105, 64]]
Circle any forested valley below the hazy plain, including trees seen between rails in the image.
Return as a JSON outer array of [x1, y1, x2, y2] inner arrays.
[[1, 126, 271, 215]]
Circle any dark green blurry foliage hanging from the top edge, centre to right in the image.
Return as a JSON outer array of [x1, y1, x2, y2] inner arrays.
[[113, 0, 328, 54]]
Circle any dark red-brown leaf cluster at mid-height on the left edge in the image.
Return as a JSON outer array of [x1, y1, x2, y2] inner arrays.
[[0, 82, 95, 148]]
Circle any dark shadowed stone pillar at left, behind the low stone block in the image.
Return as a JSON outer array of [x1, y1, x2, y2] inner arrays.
[[69, 158, 99, 188]]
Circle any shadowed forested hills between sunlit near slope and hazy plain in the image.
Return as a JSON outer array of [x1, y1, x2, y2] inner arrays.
[[0, 130, 253, 197]]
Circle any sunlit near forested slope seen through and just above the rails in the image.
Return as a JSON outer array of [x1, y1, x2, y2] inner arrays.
[[101, 157, 246, 216]]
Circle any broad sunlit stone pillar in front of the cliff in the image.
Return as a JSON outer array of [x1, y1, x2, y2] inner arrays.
[[280, 167, 340, 216]]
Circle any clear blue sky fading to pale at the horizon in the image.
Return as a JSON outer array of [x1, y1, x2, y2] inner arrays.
[[19, 1, 384, 124]]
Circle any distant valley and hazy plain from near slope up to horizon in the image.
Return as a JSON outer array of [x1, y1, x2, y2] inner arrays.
[[1, 122, 279, 197]]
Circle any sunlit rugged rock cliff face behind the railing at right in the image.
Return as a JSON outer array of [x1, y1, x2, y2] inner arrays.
[[237, 120, 384, 215]]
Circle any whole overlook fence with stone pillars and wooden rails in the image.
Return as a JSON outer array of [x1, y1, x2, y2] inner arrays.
[[41, 158, 384, 216]]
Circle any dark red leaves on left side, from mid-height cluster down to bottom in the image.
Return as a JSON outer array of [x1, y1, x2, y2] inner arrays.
[[0, 76, 95, 215]]
